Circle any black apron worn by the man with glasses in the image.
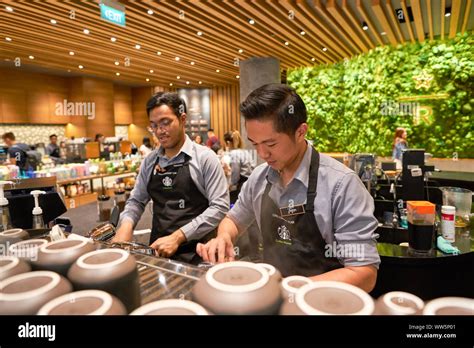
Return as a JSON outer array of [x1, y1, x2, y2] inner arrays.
[[147, 155, 215, 264]]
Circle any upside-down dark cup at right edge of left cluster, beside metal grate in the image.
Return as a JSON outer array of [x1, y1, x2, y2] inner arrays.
[[68, 249, 141, 313]]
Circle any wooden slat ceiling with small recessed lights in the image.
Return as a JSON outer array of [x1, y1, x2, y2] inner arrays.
[[0, 0, 474, 87]]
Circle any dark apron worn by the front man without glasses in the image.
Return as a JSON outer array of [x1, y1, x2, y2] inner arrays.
[[260, 148, 343, 277]]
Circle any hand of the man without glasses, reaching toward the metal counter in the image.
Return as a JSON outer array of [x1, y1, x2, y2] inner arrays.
[[196, 233, 235, 263]]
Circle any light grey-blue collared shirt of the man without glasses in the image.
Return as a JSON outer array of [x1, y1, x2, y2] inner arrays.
[[228, 144, 380, 268]]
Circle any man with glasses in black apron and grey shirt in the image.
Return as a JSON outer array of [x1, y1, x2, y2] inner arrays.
[[114, 92, 229, 264]]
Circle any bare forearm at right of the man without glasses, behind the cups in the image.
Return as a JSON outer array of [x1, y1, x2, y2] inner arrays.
[[310, 266, 377, 292]]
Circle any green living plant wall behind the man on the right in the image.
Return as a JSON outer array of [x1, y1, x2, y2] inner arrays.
[[288, 33, 474, 158]]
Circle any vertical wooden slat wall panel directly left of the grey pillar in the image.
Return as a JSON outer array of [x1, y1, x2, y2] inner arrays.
[[211, 85, 240, 144]]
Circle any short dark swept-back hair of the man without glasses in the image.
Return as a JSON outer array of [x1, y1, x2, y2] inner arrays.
[[240, 83, 307, 136]]
